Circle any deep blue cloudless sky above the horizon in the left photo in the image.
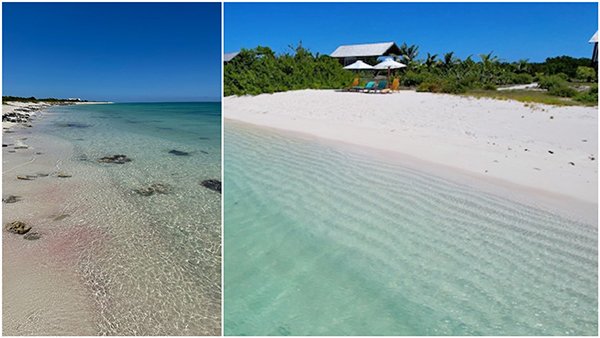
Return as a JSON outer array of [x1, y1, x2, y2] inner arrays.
[[2, 3, 221, 102]]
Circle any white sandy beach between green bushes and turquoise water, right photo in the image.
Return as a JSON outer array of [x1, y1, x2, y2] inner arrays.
[[223, 90, 598, 217]]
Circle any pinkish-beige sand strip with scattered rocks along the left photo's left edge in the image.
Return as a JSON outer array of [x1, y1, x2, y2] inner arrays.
[[2, 105, 95, 335]]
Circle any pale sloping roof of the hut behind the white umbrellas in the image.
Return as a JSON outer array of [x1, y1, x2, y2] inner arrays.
[[330, 42, 400, 66]]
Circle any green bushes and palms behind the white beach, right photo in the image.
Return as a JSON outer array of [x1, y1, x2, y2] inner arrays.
[[224, 43, 598, 105]]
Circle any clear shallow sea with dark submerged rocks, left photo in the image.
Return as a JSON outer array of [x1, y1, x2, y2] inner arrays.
[[8, 103, 221, 335]]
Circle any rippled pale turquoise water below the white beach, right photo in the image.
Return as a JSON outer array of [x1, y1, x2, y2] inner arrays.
[[224, 122, 598, 335]]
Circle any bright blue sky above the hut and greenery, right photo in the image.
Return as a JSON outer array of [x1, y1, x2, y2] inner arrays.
[[224, 3, 598, 61]]
